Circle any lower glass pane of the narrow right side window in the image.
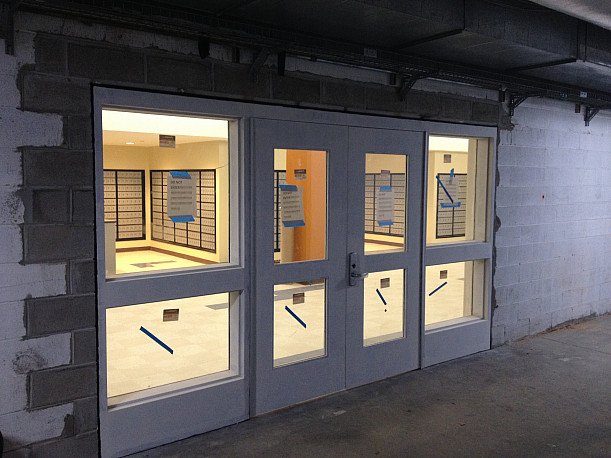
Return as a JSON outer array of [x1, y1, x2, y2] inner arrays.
[[424, 260, 486, 327]]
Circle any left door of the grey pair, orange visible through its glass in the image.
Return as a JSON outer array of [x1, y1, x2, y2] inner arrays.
[[251, 119, 348, 414]]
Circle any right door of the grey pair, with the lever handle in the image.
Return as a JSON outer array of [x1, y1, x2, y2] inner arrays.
[[346, 127, 423, 387]]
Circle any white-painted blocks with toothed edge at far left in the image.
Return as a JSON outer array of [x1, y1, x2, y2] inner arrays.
[[0, 34, 72, 451]]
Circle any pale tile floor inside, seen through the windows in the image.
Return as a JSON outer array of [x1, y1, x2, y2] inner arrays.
[[106, 247, 476, 398]]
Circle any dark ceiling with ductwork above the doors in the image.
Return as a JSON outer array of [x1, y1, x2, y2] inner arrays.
[[4, 0, 611, 108]]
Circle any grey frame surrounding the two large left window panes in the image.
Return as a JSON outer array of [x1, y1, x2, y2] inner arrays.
[[93, 86, 250, 457]]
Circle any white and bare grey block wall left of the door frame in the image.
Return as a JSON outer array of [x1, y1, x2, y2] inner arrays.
[[0, 24, 97, 457]]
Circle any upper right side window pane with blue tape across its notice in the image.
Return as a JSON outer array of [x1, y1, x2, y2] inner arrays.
[[426, 136, 488, 244]]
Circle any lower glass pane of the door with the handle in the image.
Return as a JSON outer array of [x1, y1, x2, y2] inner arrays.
[[363, 269, 404, 346]]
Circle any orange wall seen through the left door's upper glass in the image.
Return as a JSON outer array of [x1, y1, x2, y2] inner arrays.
[[286, 150, 327, 261]]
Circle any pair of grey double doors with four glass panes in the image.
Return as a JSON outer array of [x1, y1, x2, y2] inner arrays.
[[251, 119, 424, 414]]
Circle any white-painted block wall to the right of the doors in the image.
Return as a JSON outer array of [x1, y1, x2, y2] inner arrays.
[[492, 99, 611, 345]]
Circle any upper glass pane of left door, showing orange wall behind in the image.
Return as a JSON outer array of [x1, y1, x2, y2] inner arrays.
[[274, 149, 327, 263]]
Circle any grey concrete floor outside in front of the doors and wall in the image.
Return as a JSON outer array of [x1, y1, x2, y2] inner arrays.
[[134, 315, 611, 458]]
